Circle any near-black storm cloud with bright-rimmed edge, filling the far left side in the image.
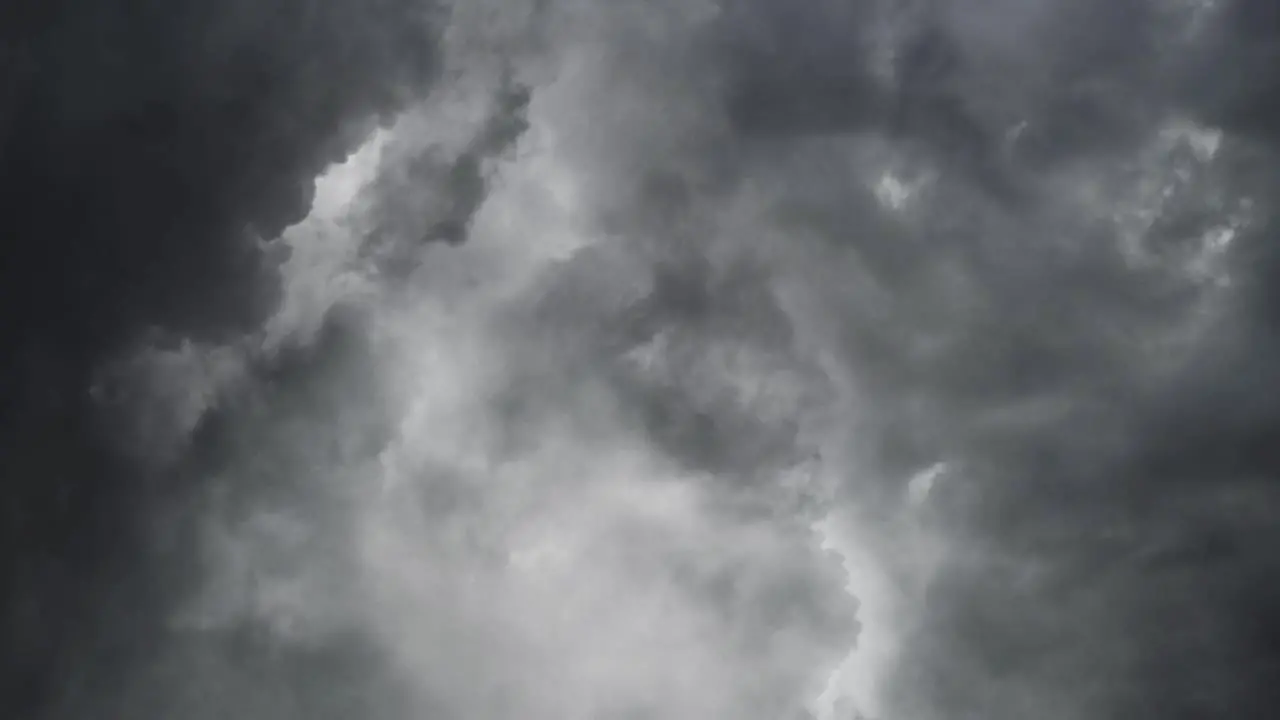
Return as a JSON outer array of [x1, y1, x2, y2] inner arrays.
[[0, 1, 435, 717]]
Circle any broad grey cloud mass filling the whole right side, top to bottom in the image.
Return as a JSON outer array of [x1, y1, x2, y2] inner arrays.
[[701, 3, 1280, 717]]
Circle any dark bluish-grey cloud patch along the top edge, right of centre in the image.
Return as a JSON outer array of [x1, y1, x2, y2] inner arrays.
[[721, 0, 1218, 210]]
